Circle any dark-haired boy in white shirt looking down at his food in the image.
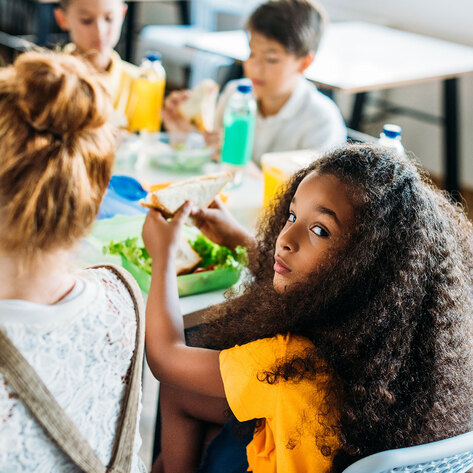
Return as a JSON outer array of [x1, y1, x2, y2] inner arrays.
[[163, 0, 346, 164]]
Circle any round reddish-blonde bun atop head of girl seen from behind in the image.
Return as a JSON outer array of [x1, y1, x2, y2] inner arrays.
[[15, 52, 111, 136]]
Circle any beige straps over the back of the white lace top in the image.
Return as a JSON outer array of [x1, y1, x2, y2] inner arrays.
[[0, 265, 144, 473]]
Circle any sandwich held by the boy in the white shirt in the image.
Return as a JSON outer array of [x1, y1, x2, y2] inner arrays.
[[179, 79, 218, 131]]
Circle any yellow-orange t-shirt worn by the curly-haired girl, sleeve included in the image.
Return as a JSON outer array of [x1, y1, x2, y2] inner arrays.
[[220, 335, 338, 473]]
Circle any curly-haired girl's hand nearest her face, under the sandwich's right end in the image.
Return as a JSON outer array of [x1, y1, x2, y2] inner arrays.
[[191, 196, 255, 250]]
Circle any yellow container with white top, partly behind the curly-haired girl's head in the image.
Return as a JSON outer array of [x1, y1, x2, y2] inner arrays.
[[261, 150, 317, 207]]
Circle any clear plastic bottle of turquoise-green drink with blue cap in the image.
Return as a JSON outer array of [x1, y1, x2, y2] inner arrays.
[[222, 81, 256, 180]]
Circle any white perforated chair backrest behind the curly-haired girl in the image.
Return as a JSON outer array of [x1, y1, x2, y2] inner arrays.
[[343, 432, 473, 473]]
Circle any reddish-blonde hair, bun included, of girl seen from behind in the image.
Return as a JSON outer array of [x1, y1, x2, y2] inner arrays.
[[0, 52, 116, 262]]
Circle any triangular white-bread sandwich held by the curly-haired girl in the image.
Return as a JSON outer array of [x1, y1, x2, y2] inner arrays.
[[141, 173, 232, 218]]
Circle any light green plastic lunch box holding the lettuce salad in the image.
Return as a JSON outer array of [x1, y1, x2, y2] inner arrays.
[[87, 215, 242, 296]]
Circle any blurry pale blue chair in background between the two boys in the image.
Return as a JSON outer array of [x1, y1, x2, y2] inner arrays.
[[135, 0, 255, 87]]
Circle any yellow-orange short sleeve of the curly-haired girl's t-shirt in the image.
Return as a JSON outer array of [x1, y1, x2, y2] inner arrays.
[[220, 335, 286, 422]]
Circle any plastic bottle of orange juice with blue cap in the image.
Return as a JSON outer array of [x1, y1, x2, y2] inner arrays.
[[126, 52, 166, 132]]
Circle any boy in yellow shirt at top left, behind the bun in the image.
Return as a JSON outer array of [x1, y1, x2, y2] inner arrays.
[[54, 0, 139, 126]]
